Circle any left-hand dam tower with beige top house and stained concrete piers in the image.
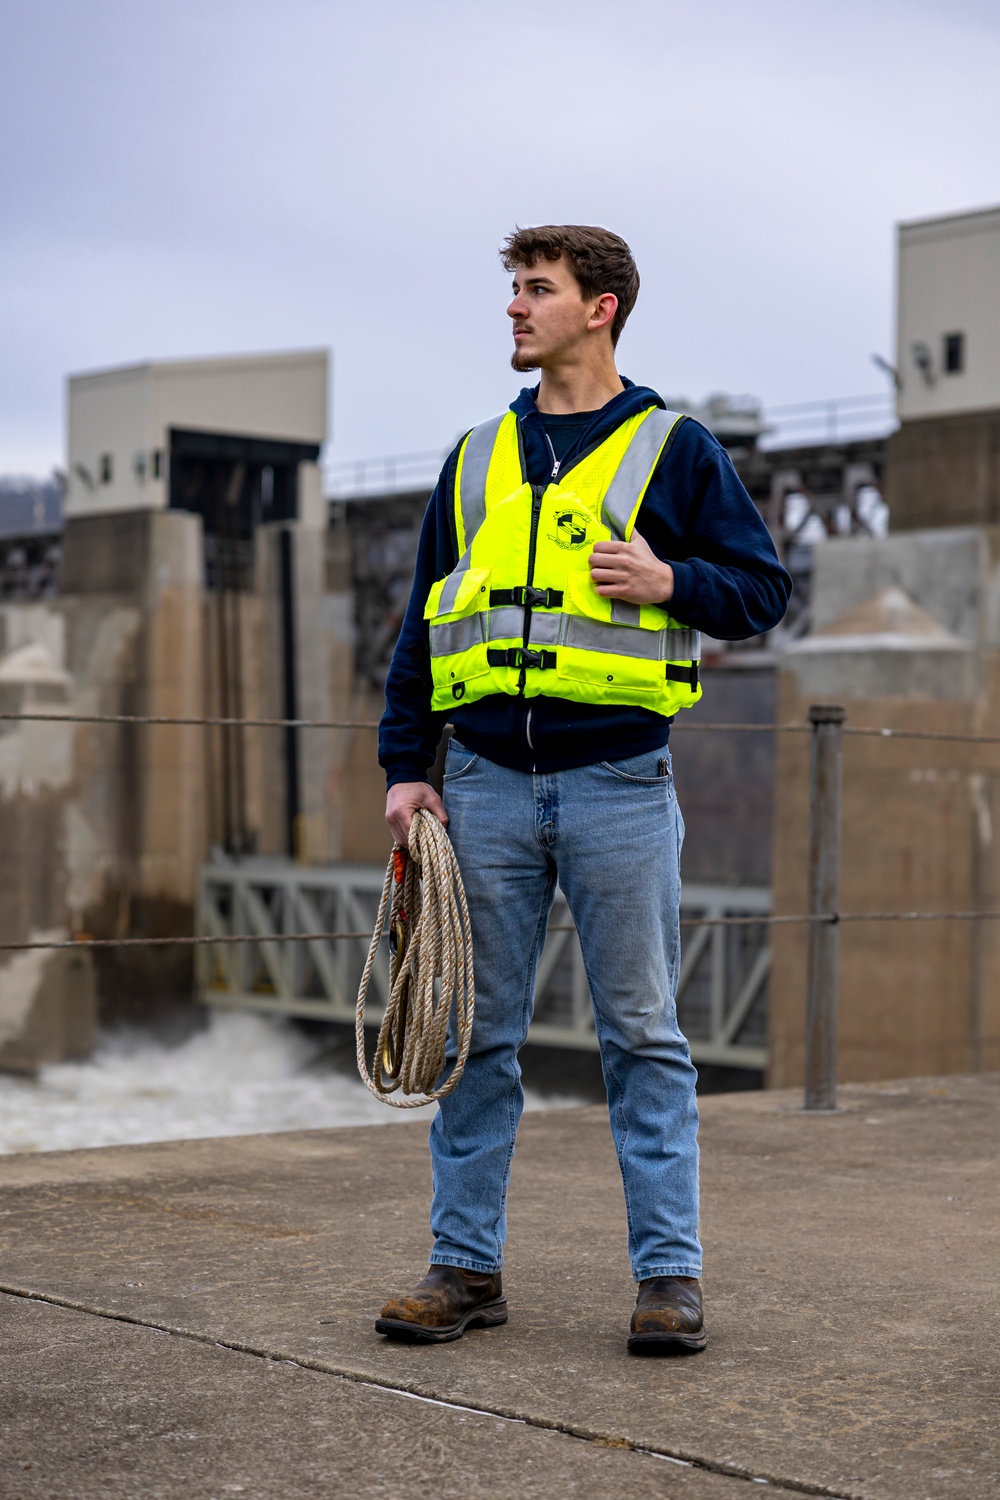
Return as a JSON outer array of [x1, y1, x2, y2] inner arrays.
[[0, 351, 382, 1067]]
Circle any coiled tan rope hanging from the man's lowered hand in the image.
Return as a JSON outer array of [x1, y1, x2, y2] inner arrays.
[[354, 810, 474, 1110]]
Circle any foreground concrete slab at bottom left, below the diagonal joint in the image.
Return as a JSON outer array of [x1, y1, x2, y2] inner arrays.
[[0, 1298, 790, 1500]]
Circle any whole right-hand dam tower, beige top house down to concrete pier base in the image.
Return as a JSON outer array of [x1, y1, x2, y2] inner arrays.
[[769, 207, 1000, 1086]]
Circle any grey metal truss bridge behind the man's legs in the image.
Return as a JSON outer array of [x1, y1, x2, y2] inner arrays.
[[196, 858, 771, 1068]]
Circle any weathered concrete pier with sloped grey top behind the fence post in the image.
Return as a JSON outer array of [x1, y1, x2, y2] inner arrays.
[[769, 527, 1000, 1086]]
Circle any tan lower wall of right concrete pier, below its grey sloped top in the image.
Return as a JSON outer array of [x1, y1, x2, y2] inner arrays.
[[768, 669, 1000, 1088]]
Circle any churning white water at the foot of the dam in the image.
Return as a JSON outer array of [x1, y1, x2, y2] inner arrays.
[[0, 1011, 576, 1155]]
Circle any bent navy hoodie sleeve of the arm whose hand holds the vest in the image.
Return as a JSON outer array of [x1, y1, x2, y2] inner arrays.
[[637, 419, 792, 641]]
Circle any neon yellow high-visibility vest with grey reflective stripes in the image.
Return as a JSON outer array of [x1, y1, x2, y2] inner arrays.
[[424, 407, 702, 714]]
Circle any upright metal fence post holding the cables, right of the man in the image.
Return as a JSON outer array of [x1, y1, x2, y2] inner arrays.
[[805, 704, 846, 1110]]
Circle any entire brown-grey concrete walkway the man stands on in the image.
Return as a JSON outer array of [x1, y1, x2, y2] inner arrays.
[[0, 1077, 1000, 1500]]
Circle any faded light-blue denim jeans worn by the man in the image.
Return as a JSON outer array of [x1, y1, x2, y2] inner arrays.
[[430, 740, 702, 1281]]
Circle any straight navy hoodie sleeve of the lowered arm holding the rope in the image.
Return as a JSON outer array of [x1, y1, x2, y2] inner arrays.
[[378, 447, 459, 788]]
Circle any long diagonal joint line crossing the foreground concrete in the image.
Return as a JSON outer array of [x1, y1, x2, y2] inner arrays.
[[0, 1283, 870, 1500]]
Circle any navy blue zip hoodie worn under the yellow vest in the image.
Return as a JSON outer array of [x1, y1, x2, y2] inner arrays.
[[378, 381, 792, 786]]
